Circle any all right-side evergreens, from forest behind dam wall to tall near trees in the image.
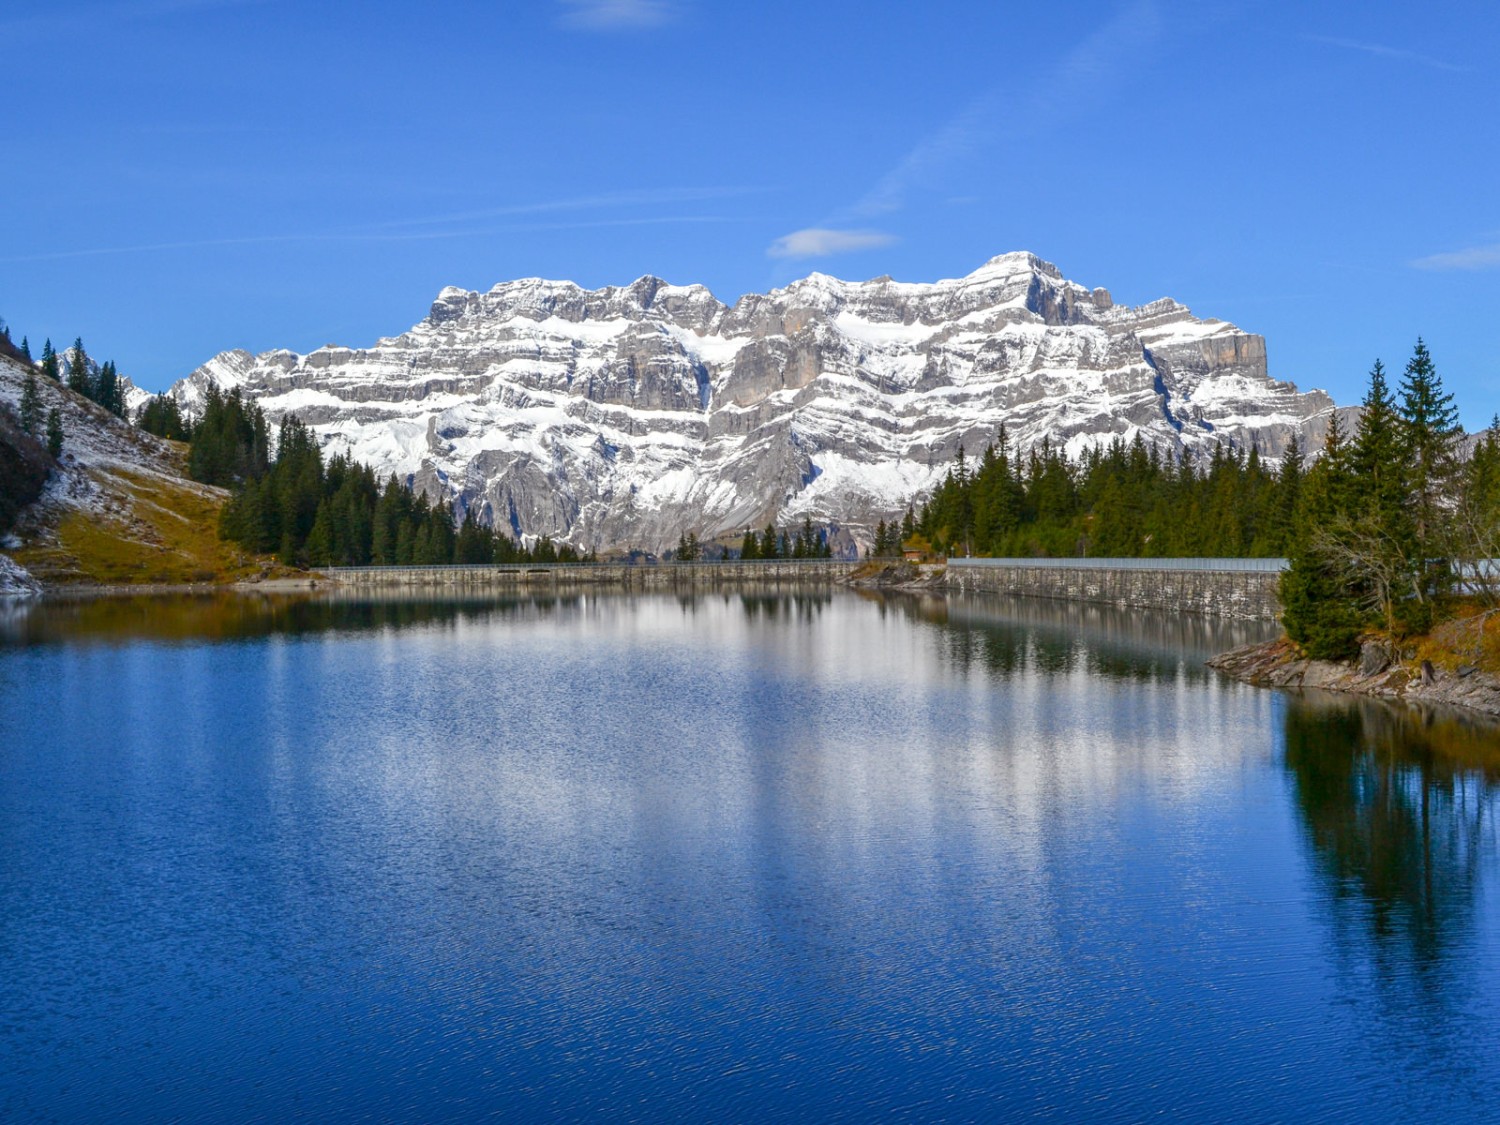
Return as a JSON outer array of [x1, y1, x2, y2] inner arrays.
[[876, 341, 1500, 659]]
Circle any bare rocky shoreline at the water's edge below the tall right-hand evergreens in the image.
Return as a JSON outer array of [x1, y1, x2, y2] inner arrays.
[[1208, 638, 1500, 719]]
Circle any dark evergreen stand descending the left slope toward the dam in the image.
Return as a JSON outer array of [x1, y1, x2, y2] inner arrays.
[[189, 389, 591, 567]]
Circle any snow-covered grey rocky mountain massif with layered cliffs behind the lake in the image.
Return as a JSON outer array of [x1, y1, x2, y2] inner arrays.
[[164, 254, 1334, 549]]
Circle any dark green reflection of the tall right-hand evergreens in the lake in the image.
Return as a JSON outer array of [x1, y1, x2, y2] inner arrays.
[[1286, 693, 1500, 974]]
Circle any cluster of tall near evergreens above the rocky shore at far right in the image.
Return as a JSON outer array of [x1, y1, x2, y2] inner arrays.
[[1281, 339, 1500, 659]]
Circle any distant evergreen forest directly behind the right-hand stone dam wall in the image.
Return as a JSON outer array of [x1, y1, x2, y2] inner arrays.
[[900, 426, 1304, 558]]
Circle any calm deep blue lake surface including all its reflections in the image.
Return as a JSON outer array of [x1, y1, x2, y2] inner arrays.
[[0, 591, 1500, 1122]]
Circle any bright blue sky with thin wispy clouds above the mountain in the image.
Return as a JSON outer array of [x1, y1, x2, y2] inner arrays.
[[0, 0, 1500, 426]]
